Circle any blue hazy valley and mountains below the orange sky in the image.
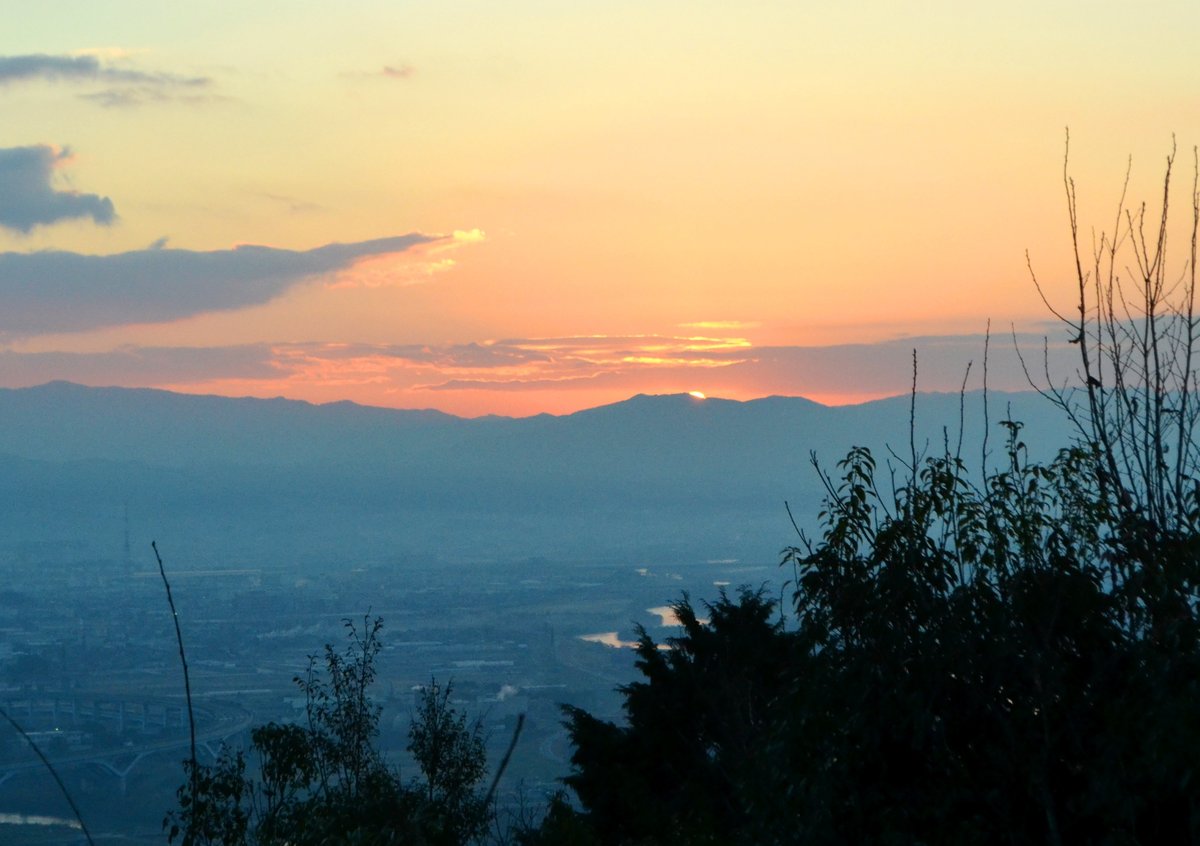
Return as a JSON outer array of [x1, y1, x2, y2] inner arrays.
[[0, 383, 1064, 842]]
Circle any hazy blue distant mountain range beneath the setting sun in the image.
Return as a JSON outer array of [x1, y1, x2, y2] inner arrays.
[[0, 382, 1069, 564]]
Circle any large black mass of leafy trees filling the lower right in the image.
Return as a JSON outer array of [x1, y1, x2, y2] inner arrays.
[[556, 424, 1200, 844]]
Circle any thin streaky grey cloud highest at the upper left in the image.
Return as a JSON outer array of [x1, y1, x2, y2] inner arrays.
[[0, 50, 212, 107]]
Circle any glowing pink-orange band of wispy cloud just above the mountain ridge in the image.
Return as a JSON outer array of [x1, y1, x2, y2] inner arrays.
[[0, 334, 1076, 410]]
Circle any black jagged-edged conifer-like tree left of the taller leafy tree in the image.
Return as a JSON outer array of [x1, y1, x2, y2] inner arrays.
[[566, 590, 791, 842]]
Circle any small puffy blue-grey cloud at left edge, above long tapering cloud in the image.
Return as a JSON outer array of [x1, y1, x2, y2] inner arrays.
[[0, 144, 116, 233]]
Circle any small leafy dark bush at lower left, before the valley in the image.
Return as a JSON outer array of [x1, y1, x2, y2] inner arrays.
[[163, 618, 490, 846]]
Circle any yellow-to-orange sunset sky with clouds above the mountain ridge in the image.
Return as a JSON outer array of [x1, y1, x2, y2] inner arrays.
[[0, 0, 1200, 416]]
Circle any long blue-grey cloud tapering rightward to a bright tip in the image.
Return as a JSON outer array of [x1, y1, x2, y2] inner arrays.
[[0, 233, 440, 335]]
